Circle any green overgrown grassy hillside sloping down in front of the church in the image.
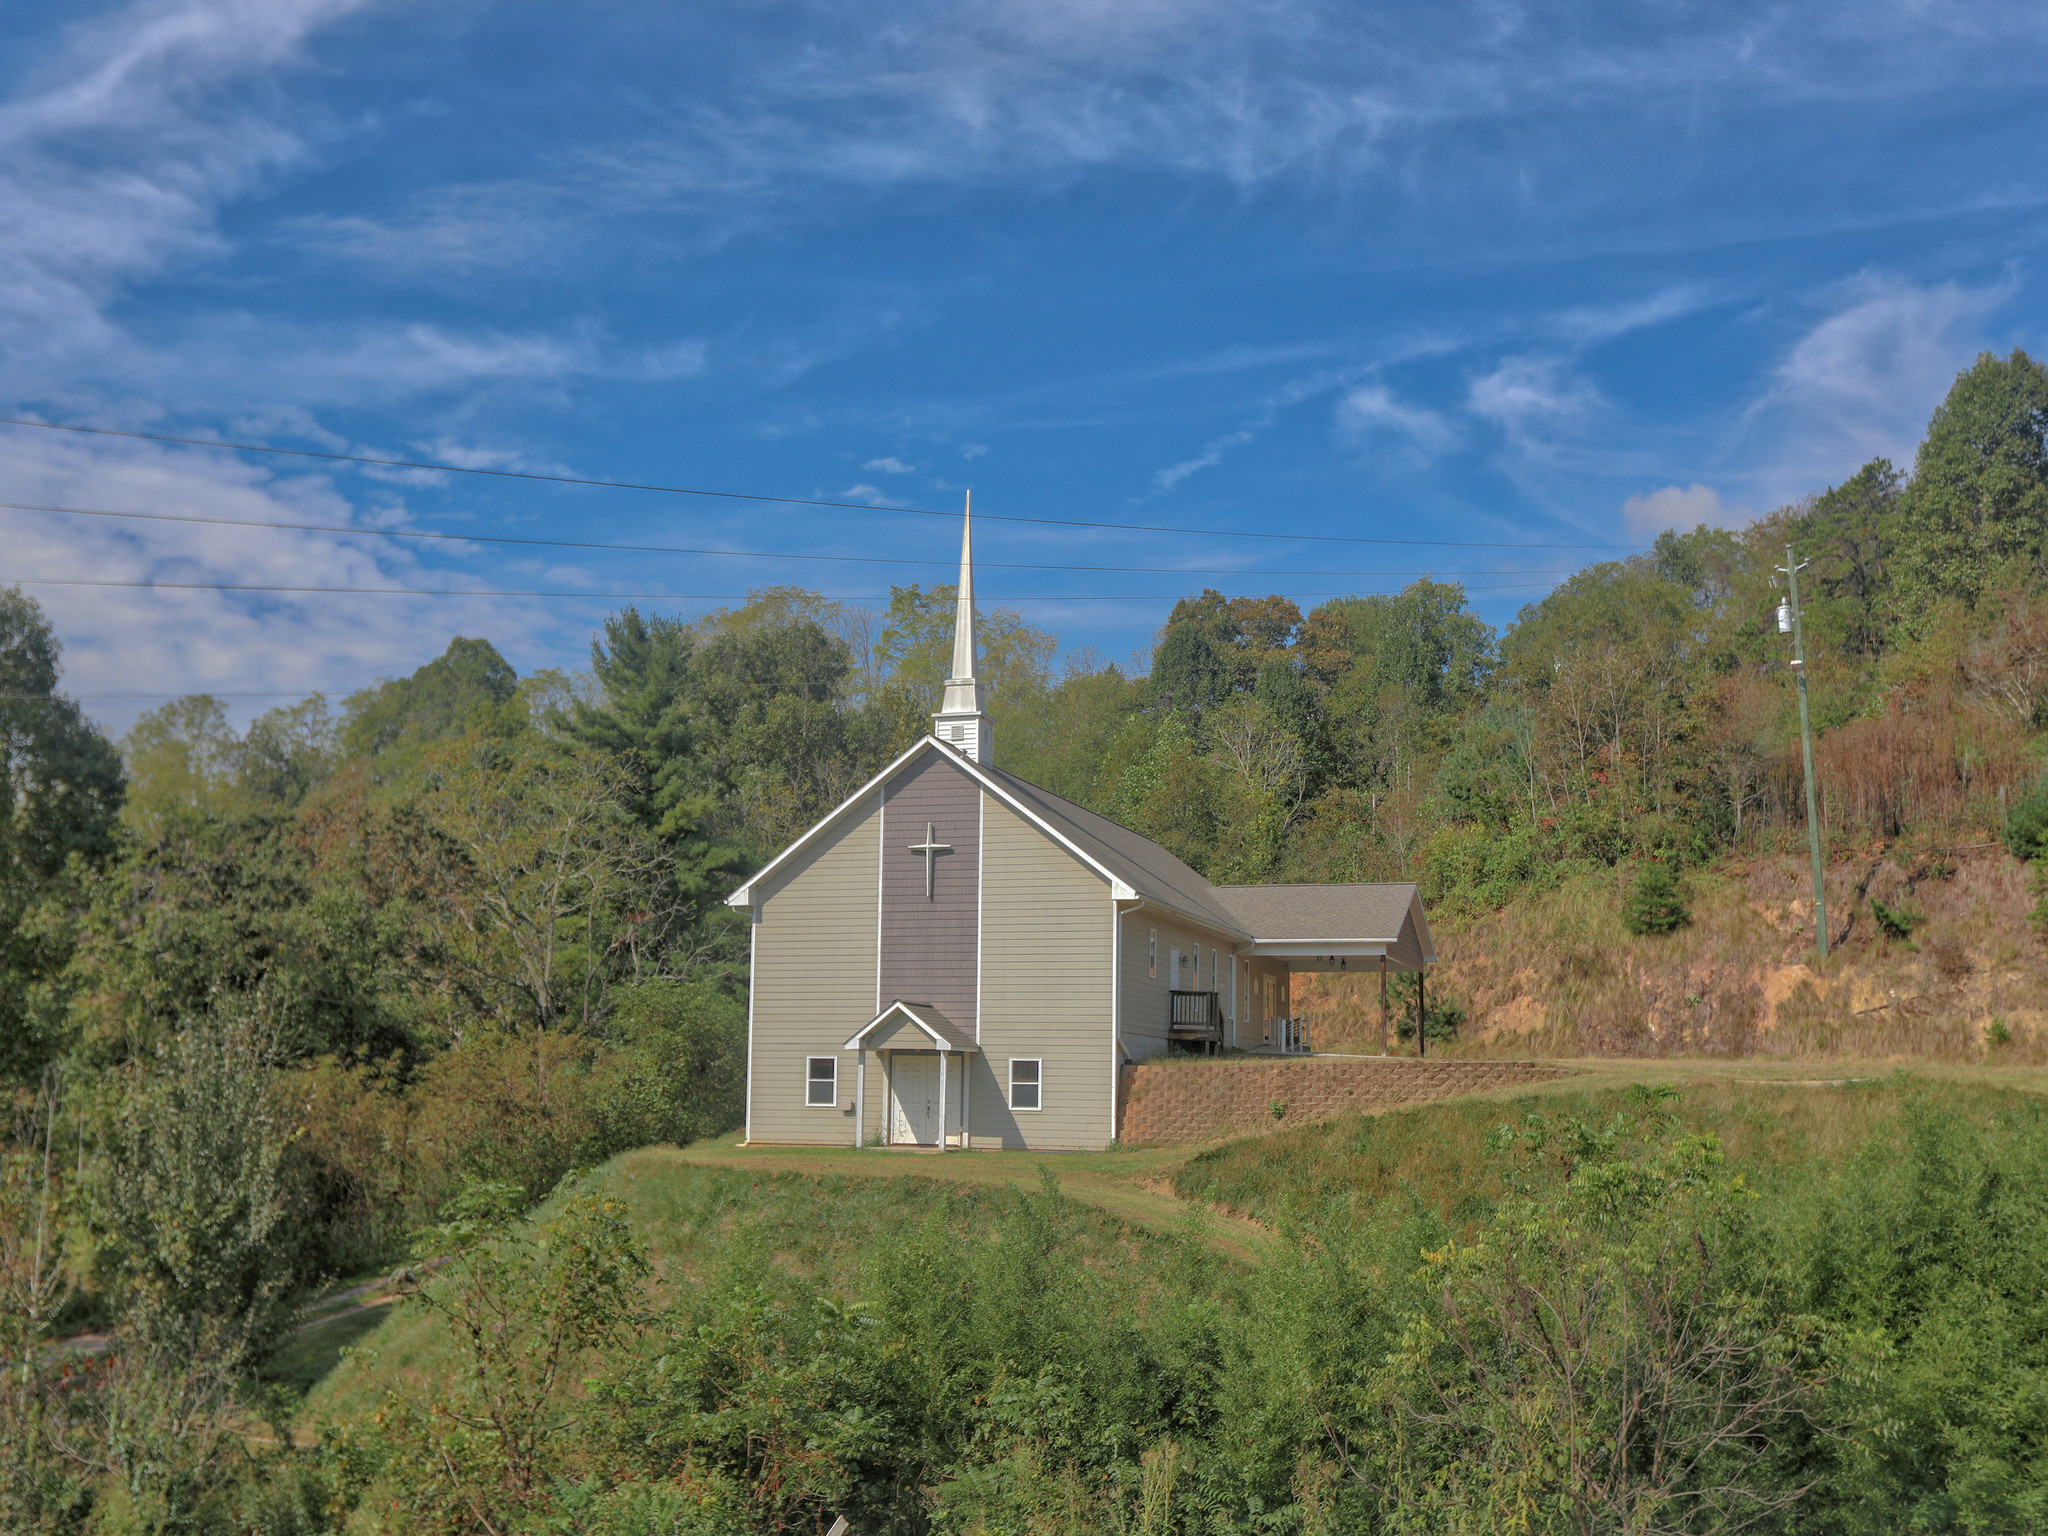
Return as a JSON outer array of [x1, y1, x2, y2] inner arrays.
[[260, 1063, 2048, 1536]]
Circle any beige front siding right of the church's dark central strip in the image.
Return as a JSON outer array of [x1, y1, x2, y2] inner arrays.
[[978, 795, 1116, 1149]]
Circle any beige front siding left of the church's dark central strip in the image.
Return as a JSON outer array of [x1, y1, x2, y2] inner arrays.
[[748, 797, 881, 1145]]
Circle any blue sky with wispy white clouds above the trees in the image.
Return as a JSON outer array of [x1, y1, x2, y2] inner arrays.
[[0, 0, 2048, 729]]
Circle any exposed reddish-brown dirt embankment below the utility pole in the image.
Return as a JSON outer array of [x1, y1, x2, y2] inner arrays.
[[1296, 848, 2048, 1063]]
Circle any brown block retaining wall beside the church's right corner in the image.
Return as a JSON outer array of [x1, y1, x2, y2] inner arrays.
[[1116, 1057, 1569, 1147]]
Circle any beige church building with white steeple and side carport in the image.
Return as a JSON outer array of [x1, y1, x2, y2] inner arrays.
[[727, 512, 1436, 1151]]
